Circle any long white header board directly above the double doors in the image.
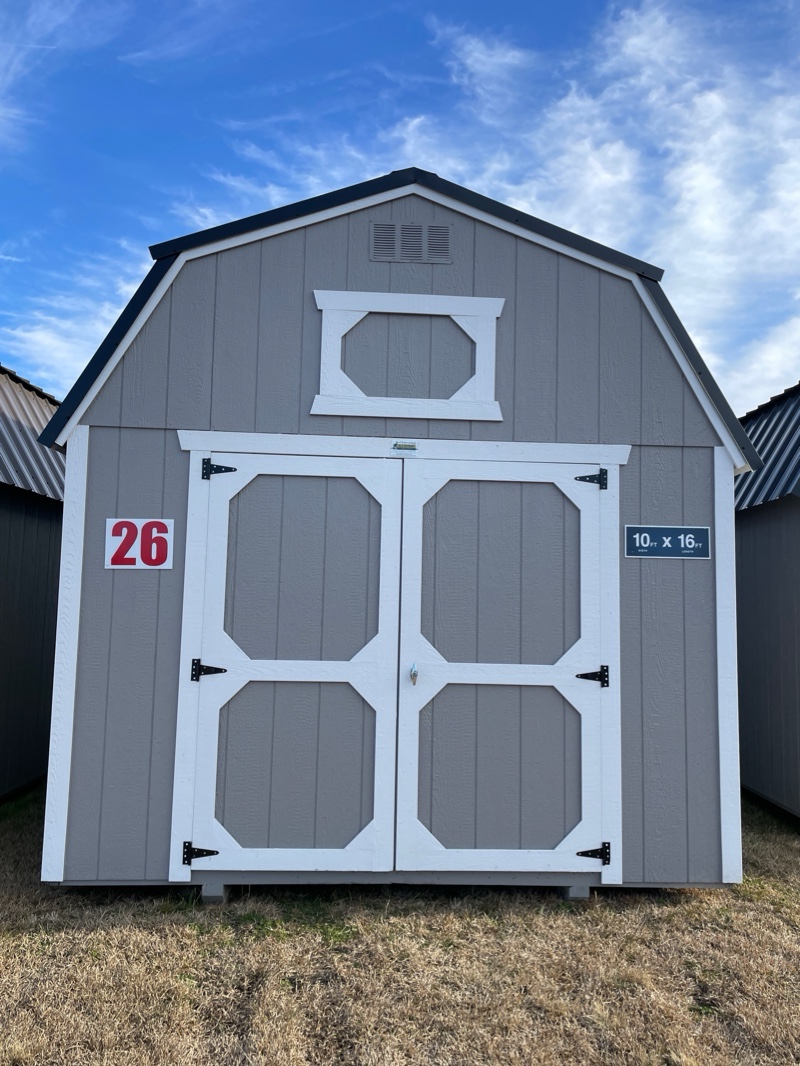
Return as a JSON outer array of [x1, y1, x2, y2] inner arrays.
[[178, 430, 630, 466]]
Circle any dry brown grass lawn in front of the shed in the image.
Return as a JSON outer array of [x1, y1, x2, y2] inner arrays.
[[0, 790, 800, 1066]]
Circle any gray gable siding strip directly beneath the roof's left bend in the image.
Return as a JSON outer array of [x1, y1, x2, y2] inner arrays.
[[166, 256, 218, 430]]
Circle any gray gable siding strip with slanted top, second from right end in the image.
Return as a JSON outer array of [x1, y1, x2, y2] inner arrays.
[[641, 314, 684, 445]]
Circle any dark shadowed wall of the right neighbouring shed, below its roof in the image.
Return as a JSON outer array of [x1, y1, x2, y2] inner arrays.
[[736, 496, 800, 815]]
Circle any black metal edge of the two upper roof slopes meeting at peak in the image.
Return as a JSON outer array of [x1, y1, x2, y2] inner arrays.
[[150, 166, 663, 281]]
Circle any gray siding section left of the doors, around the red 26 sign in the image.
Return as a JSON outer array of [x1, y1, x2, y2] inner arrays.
[[65, 430, 189, 881]]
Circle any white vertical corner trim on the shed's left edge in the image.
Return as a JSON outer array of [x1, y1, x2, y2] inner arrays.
[[42, 425, 89, 882]]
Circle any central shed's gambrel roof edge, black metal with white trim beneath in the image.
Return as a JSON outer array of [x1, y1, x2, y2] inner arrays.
[[39, 167, 761, 469]]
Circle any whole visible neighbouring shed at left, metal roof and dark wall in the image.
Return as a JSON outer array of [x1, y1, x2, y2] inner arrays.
[[0, 366, 64, 796]]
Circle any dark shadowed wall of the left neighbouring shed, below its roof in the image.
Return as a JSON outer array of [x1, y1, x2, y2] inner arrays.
[[0, 484, 63, 796]]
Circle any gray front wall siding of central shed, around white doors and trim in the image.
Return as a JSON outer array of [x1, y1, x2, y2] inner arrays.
[[65, 196, 721, 884]]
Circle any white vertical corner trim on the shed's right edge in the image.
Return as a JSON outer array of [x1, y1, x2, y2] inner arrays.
[[714, 448, 741, 884]]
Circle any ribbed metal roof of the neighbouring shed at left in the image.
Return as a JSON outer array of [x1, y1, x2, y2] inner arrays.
[[0, 365, 64, 500]]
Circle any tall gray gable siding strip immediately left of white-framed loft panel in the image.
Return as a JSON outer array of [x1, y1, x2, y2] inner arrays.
[[255, 229, 307, 433]]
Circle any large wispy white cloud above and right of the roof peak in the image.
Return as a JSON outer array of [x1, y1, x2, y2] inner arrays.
[[196, 0, 800, 408]]
